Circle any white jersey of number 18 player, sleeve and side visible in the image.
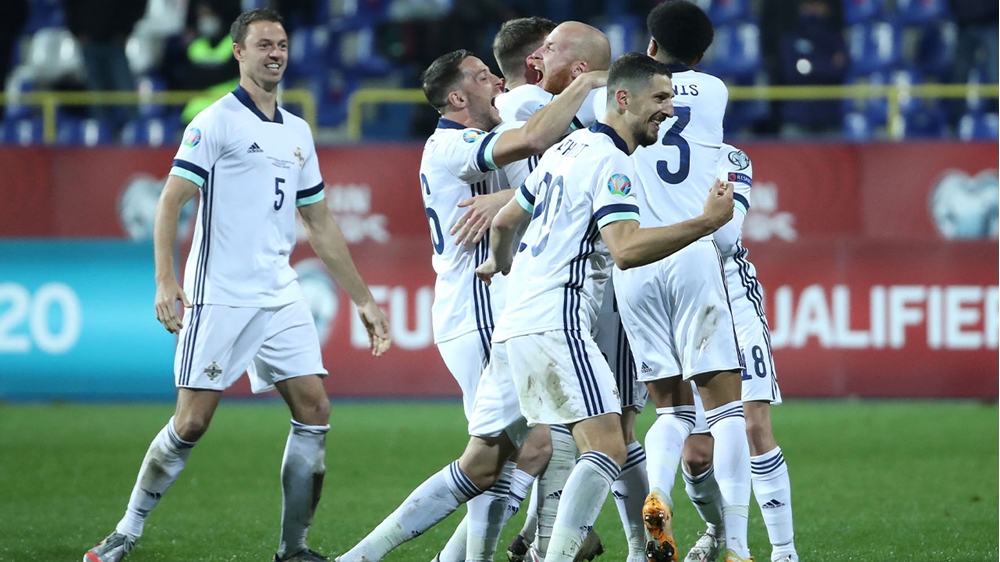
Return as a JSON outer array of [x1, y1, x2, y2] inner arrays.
[[714, 144, 764, 327]]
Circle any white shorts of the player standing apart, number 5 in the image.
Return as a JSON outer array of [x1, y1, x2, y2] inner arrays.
[[174, 301, 327, 393]]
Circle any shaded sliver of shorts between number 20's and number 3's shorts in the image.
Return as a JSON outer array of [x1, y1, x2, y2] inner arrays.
[[594, 279, 649, 413]]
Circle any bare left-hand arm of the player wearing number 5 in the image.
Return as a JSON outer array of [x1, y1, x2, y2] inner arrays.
[[153, 176, 198, 334]]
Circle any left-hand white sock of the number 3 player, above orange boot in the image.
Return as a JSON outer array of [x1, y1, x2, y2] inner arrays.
[[646, 406, 695, 496]]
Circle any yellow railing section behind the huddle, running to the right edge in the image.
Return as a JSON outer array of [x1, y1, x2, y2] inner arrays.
[[347, 84, 1000, 141]]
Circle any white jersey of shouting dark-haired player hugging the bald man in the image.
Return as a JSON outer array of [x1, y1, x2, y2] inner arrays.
[[420, 119, 509, 345]]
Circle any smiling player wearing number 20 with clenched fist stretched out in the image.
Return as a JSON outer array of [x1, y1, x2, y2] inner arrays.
[[338, 51, 732, 562]]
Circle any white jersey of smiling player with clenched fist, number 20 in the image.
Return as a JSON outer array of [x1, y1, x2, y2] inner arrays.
[[493, 123, 639, 342]]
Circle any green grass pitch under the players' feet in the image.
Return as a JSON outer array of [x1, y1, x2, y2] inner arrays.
[[0, 401, 1000, 562]]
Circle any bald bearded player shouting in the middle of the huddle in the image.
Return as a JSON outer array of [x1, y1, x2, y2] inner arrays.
[[497, 21, 649, 562]]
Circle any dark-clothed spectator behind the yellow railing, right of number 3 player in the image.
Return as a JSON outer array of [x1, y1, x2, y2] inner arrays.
[[778, 0, 849, 137]]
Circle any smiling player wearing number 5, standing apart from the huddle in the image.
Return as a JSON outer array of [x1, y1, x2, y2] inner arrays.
[[83, 9, 389, 562]]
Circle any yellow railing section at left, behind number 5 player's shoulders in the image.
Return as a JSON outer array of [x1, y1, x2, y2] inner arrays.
[[0, 90, 316, 144]]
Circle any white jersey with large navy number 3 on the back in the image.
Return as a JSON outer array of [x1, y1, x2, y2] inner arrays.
[[632, 64, 729, 227]]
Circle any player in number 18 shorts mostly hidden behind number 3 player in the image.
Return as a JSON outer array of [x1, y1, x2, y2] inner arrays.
[[683, 144, 799, 562]]
